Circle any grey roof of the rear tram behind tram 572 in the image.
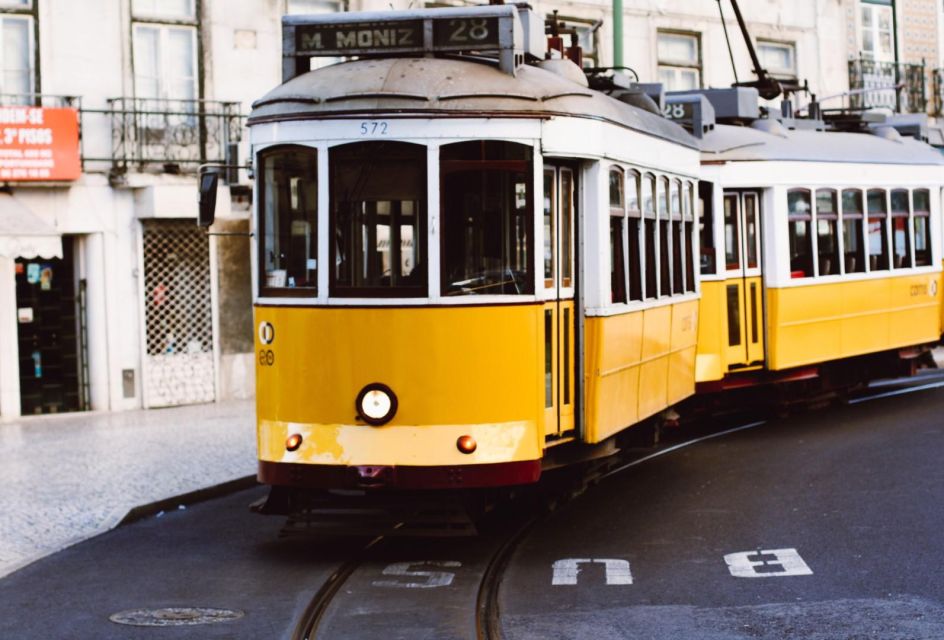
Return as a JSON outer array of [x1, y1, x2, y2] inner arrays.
[[702, 125, 944, 165]]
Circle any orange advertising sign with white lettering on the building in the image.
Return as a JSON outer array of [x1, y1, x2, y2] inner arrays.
[[0, 107, 82, 182]]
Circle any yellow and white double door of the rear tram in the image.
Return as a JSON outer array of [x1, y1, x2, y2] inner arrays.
[[724, 191, 764, 370]]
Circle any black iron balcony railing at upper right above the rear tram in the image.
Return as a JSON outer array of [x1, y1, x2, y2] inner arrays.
[[849, 58, 928, 113]]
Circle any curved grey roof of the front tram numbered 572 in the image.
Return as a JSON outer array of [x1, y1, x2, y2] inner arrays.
[[249, 58, 698, 149]]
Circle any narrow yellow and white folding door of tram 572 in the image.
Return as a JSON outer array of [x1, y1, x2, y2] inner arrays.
[[544, 166, 576, 438]]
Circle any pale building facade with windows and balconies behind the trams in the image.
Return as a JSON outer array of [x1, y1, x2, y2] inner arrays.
[[0, 0, 942, 418]]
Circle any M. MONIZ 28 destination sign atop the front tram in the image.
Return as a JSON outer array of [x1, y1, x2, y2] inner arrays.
[[282, 5, 524, 81]]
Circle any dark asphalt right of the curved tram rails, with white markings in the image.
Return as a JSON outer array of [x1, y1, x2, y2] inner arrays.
[[501, 389, 944, 640]]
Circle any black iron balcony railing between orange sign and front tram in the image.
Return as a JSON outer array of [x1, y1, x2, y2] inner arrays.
[[99, 98, 242, 175]]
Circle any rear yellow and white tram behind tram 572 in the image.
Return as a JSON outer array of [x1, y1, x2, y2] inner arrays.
[[680, 94, 944, 400]]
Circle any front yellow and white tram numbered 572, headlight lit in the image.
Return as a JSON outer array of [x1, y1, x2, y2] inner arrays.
[[240, 6, 699, 488]]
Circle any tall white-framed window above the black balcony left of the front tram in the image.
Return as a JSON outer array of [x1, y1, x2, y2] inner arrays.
[[132, 0, 199, 100]]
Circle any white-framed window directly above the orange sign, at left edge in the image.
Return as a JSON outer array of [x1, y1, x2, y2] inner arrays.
[[0, 0, 32, 104]]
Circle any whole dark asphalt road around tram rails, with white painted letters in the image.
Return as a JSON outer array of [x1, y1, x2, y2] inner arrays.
[[0, 382, 944, 640]]
